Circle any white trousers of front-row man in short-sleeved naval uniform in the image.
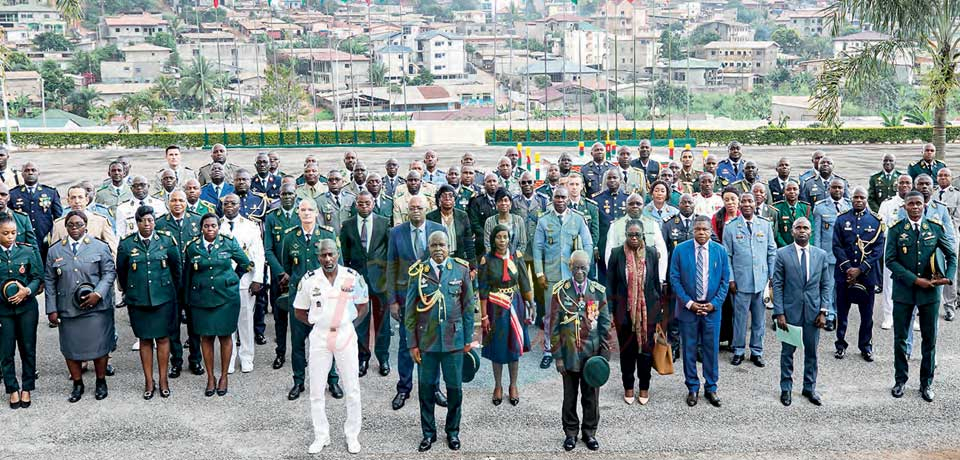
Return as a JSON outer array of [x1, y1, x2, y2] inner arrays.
[[309, 325, 361, 443]]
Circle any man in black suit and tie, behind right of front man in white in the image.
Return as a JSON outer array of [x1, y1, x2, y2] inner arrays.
[[340, 190, 390, 377]]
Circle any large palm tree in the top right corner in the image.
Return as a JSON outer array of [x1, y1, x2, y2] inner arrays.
[[812, 0, 960, 159]]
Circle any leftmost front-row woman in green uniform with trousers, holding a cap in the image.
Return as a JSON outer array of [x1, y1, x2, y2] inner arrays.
[[0, 215, 43, 409]]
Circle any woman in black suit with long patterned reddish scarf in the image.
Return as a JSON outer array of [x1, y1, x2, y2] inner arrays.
[[607, 220, 668, 405]]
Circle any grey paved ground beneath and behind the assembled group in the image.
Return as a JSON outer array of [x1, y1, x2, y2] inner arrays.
[[0, 145, 960, 459]]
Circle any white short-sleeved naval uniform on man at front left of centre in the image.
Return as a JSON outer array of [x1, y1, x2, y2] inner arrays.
[[293, 265, 368, 450]]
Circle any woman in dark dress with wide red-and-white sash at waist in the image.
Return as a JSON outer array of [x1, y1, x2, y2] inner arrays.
[[478, 225, 536, 406]]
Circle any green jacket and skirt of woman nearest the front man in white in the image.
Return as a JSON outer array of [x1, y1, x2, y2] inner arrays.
[[183, 234, 253, 337]]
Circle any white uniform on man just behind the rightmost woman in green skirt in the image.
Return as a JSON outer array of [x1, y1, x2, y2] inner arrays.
[[220, 214, 265, 373]]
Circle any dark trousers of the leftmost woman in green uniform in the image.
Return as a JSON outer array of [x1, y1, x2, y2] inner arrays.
[[0, 308, 40, 394]]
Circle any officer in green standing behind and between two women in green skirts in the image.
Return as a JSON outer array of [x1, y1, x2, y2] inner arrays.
[[154, 191, 204, 378]]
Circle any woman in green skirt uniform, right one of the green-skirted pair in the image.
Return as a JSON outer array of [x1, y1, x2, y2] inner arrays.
[[183, 214, 253, 397]]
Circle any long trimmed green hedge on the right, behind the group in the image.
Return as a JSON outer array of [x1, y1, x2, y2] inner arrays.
[[485, 126, 960, 145]]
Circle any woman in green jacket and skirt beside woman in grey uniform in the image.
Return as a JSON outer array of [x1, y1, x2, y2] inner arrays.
[[117, 206, 181, 400]]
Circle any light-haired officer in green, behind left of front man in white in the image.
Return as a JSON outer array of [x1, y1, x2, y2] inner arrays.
[[280, 200, 343, 401]]
